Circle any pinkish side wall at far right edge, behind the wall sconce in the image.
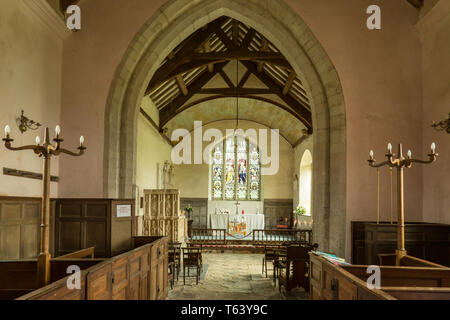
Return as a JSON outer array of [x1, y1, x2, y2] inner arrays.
[[418, 0, 450, 224]]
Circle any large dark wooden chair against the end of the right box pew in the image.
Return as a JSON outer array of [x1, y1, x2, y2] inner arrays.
[[278, 245, 318, 292]]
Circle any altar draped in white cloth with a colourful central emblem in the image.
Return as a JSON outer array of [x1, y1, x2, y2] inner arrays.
[[209, 214, 265, 237]]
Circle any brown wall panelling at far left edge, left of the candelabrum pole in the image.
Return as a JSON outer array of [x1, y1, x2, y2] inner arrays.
[[0, 197, 42, 260]]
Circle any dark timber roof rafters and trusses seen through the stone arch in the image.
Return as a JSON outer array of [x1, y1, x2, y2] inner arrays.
[[146, 17, 312, 132]]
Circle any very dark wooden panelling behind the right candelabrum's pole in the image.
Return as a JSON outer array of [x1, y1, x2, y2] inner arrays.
[[352, 221, 450, 266]]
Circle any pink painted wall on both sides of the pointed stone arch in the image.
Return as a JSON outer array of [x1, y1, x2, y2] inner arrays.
[[59, 0, 428, 255]]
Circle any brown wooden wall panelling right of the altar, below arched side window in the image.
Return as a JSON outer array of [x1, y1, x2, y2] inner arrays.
[[264, 199, 294, 229]]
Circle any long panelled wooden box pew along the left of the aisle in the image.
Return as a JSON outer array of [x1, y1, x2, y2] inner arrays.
[[18, 237, 168, 300]]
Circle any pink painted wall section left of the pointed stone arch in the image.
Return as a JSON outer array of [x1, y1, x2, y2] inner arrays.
[[59, 0, 164, 198]]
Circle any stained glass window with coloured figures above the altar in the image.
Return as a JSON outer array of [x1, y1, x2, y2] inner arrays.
[[211, 136, 261, 200]]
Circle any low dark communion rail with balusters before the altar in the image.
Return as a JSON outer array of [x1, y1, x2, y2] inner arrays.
[[189, 228, 312, 246]]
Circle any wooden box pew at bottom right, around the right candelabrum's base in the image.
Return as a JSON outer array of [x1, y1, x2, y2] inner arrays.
[[309, 253, 450, 300]]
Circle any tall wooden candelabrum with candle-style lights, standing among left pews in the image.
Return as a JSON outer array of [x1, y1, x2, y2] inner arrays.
[[2, 126, 86, 287]]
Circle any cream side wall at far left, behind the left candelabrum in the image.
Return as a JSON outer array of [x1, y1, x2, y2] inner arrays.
[[0, 0, 63, 197]]
